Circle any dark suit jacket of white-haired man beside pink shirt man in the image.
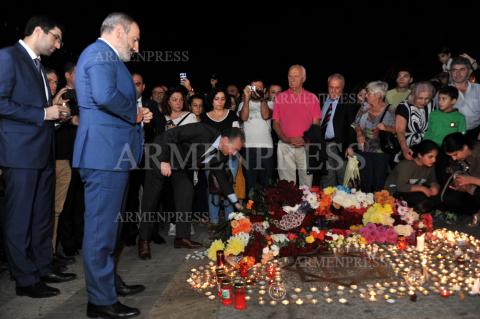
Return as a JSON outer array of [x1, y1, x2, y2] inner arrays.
[[324, 103, 360, 153]]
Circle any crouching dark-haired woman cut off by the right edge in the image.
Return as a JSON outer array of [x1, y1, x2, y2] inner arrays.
[[442, 133, 480, 226]]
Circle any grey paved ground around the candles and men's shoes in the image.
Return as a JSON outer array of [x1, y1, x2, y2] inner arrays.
[[0, 218, 480, 319]]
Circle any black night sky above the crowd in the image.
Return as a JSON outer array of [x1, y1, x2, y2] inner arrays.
[[0, 1, 480, 92]]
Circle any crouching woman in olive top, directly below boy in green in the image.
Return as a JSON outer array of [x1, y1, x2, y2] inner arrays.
[[385, 140, 440, 213]]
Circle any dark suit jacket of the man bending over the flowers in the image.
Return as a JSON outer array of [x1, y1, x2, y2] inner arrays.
[[154, 123, 234, 196]]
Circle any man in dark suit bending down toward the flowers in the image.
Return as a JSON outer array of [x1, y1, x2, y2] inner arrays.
[[139, 123, 245, 258]]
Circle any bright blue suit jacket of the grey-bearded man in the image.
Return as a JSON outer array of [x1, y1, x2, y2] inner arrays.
[[73, 40, 143, 171]]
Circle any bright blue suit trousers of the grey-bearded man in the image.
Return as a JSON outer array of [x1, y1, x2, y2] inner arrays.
[[80, 168, 128, 305]]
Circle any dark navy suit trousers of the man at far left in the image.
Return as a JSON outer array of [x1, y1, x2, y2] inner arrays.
[[2, 163, 54, 287]]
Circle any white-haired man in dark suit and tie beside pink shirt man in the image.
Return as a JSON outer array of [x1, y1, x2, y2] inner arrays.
[[314, 73, 359, 187]]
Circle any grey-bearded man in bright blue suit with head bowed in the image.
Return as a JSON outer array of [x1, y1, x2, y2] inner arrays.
[[73, 13, 152, 318]]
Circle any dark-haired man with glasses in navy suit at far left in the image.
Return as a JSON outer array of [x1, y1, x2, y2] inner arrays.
[[0, 16, 76, 298]]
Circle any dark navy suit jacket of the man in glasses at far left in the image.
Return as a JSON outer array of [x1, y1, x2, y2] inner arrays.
[[0, 43, 54, 169]]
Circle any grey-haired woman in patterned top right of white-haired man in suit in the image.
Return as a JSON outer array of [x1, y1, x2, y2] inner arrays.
[[349, 81, 395, 192]]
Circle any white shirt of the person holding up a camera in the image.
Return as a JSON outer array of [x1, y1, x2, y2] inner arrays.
[[237, 100, 273, 148]]
